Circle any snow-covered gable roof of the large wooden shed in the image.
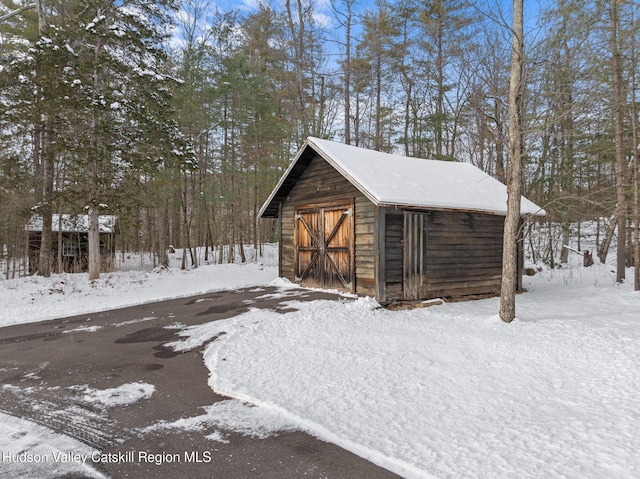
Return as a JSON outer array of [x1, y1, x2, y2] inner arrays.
[[260, 137, 545, 217]]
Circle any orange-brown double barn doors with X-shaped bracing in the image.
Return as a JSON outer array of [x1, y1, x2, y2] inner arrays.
[[295, 204, 354, 291]]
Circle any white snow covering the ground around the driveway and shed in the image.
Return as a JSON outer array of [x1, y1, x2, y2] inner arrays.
[[0, 244, 640, 478]]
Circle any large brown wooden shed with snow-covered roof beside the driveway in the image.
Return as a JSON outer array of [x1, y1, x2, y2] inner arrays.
[[260, 137, 545, 302]]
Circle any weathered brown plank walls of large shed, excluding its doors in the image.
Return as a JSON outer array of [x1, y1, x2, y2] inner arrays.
[[280, 156, 504, 301]]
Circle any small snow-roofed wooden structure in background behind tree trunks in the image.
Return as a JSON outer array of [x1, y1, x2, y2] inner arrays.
[[25, 214, 117, 274]]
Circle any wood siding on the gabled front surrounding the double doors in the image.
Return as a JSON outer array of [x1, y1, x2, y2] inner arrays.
[[280, 156, 374, 295]]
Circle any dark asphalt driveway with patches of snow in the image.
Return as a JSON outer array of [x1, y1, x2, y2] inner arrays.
[[0, 287, 398, 479]]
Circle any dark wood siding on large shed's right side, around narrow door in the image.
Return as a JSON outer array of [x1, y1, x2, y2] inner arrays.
[[385, 209, 504, 300]]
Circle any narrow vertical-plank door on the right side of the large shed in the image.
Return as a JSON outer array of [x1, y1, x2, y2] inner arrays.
[[403, 212, 427, 300]]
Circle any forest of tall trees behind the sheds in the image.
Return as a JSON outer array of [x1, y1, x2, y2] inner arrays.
[[0, 0, 640, 288]]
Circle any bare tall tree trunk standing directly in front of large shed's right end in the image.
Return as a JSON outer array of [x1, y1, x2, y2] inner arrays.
[[500, 0, 524, 323]]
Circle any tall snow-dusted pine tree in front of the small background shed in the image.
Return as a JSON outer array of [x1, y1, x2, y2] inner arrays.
[[3, 0, 193, 280]]
